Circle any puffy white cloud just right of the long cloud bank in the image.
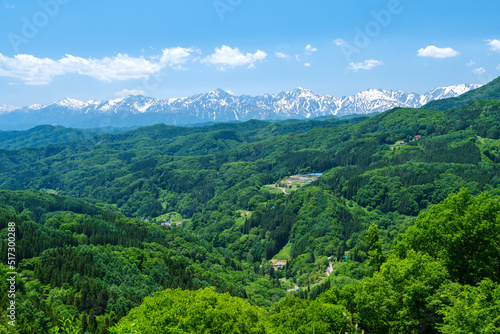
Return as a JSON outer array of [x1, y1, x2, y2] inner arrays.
[[203, 45, 267, 71]]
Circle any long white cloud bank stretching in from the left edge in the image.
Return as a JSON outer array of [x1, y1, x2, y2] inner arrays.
[[0, 48, 194, 85]]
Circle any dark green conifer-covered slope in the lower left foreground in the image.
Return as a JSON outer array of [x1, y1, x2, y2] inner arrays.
[[0, 191, 260, 333]]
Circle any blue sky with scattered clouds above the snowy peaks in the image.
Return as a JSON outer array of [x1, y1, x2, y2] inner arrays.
[[0, 0, 500, 106]]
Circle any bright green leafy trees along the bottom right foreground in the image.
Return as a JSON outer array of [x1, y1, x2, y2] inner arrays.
[[111, 190, 500, 334]]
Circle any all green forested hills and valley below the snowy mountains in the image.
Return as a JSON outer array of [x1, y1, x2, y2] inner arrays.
[[0, 79, 500, 334]]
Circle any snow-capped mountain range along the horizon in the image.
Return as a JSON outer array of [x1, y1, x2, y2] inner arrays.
[[0, 84, 480, 130]]
